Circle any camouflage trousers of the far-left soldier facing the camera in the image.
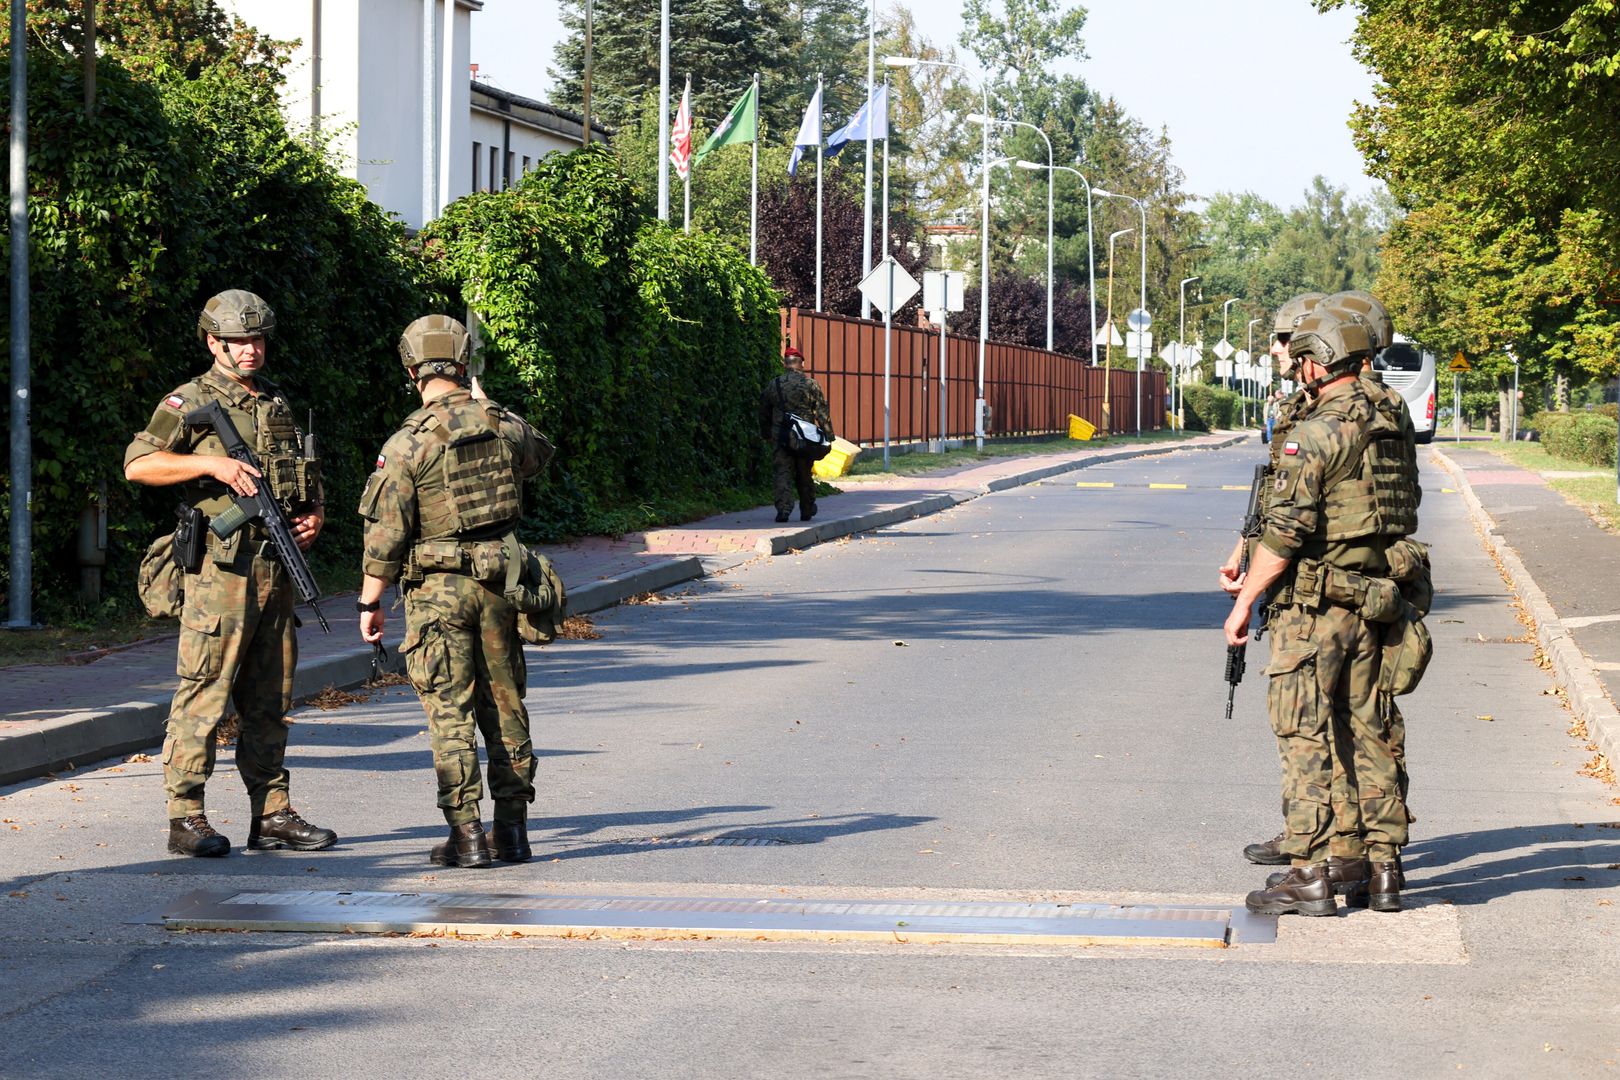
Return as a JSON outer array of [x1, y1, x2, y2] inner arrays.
[[164, 546, 298, 818]]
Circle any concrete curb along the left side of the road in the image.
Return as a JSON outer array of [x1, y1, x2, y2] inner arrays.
[[0, 434, 1251, 784]]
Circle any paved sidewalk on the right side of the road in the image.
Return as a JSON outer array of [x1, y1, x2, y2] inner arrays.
[[1434, 444, 1620, 764]]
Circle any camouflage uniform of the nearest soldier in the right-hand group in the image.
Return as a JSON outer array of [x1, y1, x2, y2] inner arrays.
[[1260, 379, 1421, 865]]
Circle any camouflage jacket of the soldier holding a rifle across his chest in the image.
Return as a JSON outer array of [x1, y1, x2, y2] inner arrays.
[[123, 366, 321, 517]]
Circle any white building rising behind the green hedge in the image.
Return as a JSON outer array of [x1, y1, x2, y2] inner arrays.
[[222, 0, 604, 228]]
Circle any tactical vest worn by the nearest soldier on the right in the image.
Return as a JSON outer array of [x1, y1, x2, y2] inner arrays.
[[1322, 387, 1422, 541]]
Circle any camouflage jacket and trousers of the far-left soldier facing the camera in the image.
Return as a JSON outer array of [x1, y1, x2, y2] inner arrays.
[[123, 368, 319, 818]]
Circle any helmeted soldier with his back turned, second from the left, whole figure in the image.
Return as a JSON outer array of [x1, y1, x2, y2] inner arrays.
[[356, 316, 551, 866]]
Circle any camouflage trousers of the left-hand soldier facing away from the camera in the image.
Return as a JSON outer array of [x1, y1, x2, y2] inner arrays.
[[400, 573, 535, 826]]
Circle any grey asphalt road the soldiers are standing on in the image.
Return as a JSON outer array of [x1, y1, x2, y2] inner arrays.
[[0, 445, 1620, 1080]]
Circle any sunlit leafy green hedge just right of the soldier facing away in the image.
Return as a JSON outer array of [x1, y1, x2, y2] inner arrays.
[[423, 147, 781, 539]]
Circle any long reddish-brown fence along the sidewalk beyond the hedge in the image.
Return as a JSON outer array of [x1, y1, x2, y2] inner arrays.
[[782, 308, 1165, 445]]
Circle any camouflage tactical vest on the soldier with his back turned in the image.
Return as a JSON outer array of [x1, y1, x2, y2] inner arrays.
[[405, 402, 523, 542]]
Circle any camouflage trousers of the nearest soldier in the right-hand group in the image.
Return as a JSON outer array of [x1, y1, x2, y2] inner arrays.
[[1267, 604, 1408, 865]]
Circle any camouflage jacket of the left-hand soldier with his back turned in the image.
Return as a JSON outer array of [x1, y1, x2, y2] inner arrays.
[[360, 387, 552, 581]]
